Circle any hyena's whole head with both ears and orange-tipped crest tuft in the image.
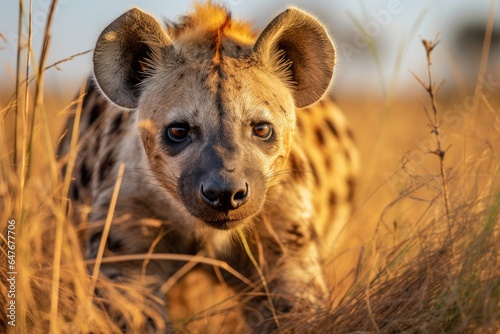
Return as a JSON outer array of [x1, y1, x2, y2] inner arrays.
[[94, 4, 335, 230]]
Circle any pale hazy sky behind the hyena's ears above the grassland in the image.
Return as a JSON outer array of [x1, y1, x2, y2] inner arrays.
[[0, 0, 500, 97]]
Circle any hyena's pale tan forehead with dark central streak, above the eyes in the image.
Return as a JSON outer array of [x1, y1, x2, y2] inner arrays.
[[138, 58, 295, 123]]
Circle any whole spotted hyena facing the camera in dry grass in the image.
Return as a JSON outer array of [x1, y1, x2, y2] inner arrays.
[[61, 3, 357, 333]]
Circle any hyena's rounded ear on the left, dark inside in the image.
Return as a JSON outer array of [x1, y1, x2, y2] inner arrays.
[[93, 8, 171, 108]]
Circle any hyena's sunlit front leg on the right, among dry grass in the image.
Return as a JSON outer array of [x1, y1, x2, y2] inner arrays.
[[234, 221, 328, 333]]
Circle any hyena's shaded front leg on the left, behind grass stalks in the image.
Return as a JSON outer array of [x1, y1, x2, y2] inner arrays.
[[86, 209, 191, 333]]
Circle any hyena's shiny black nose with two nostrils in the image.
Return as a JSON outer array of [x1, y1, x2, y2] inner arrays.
[[200, 180, 250, 211]]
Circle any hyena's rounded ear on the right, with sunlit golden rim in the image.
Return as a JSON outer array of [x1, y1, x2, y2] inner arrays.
[[254, 8, 335, 108]]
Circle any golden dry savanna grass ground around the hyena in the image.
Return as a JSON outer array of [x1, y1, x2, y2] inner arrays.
[[0, 1, 500, 333]]
